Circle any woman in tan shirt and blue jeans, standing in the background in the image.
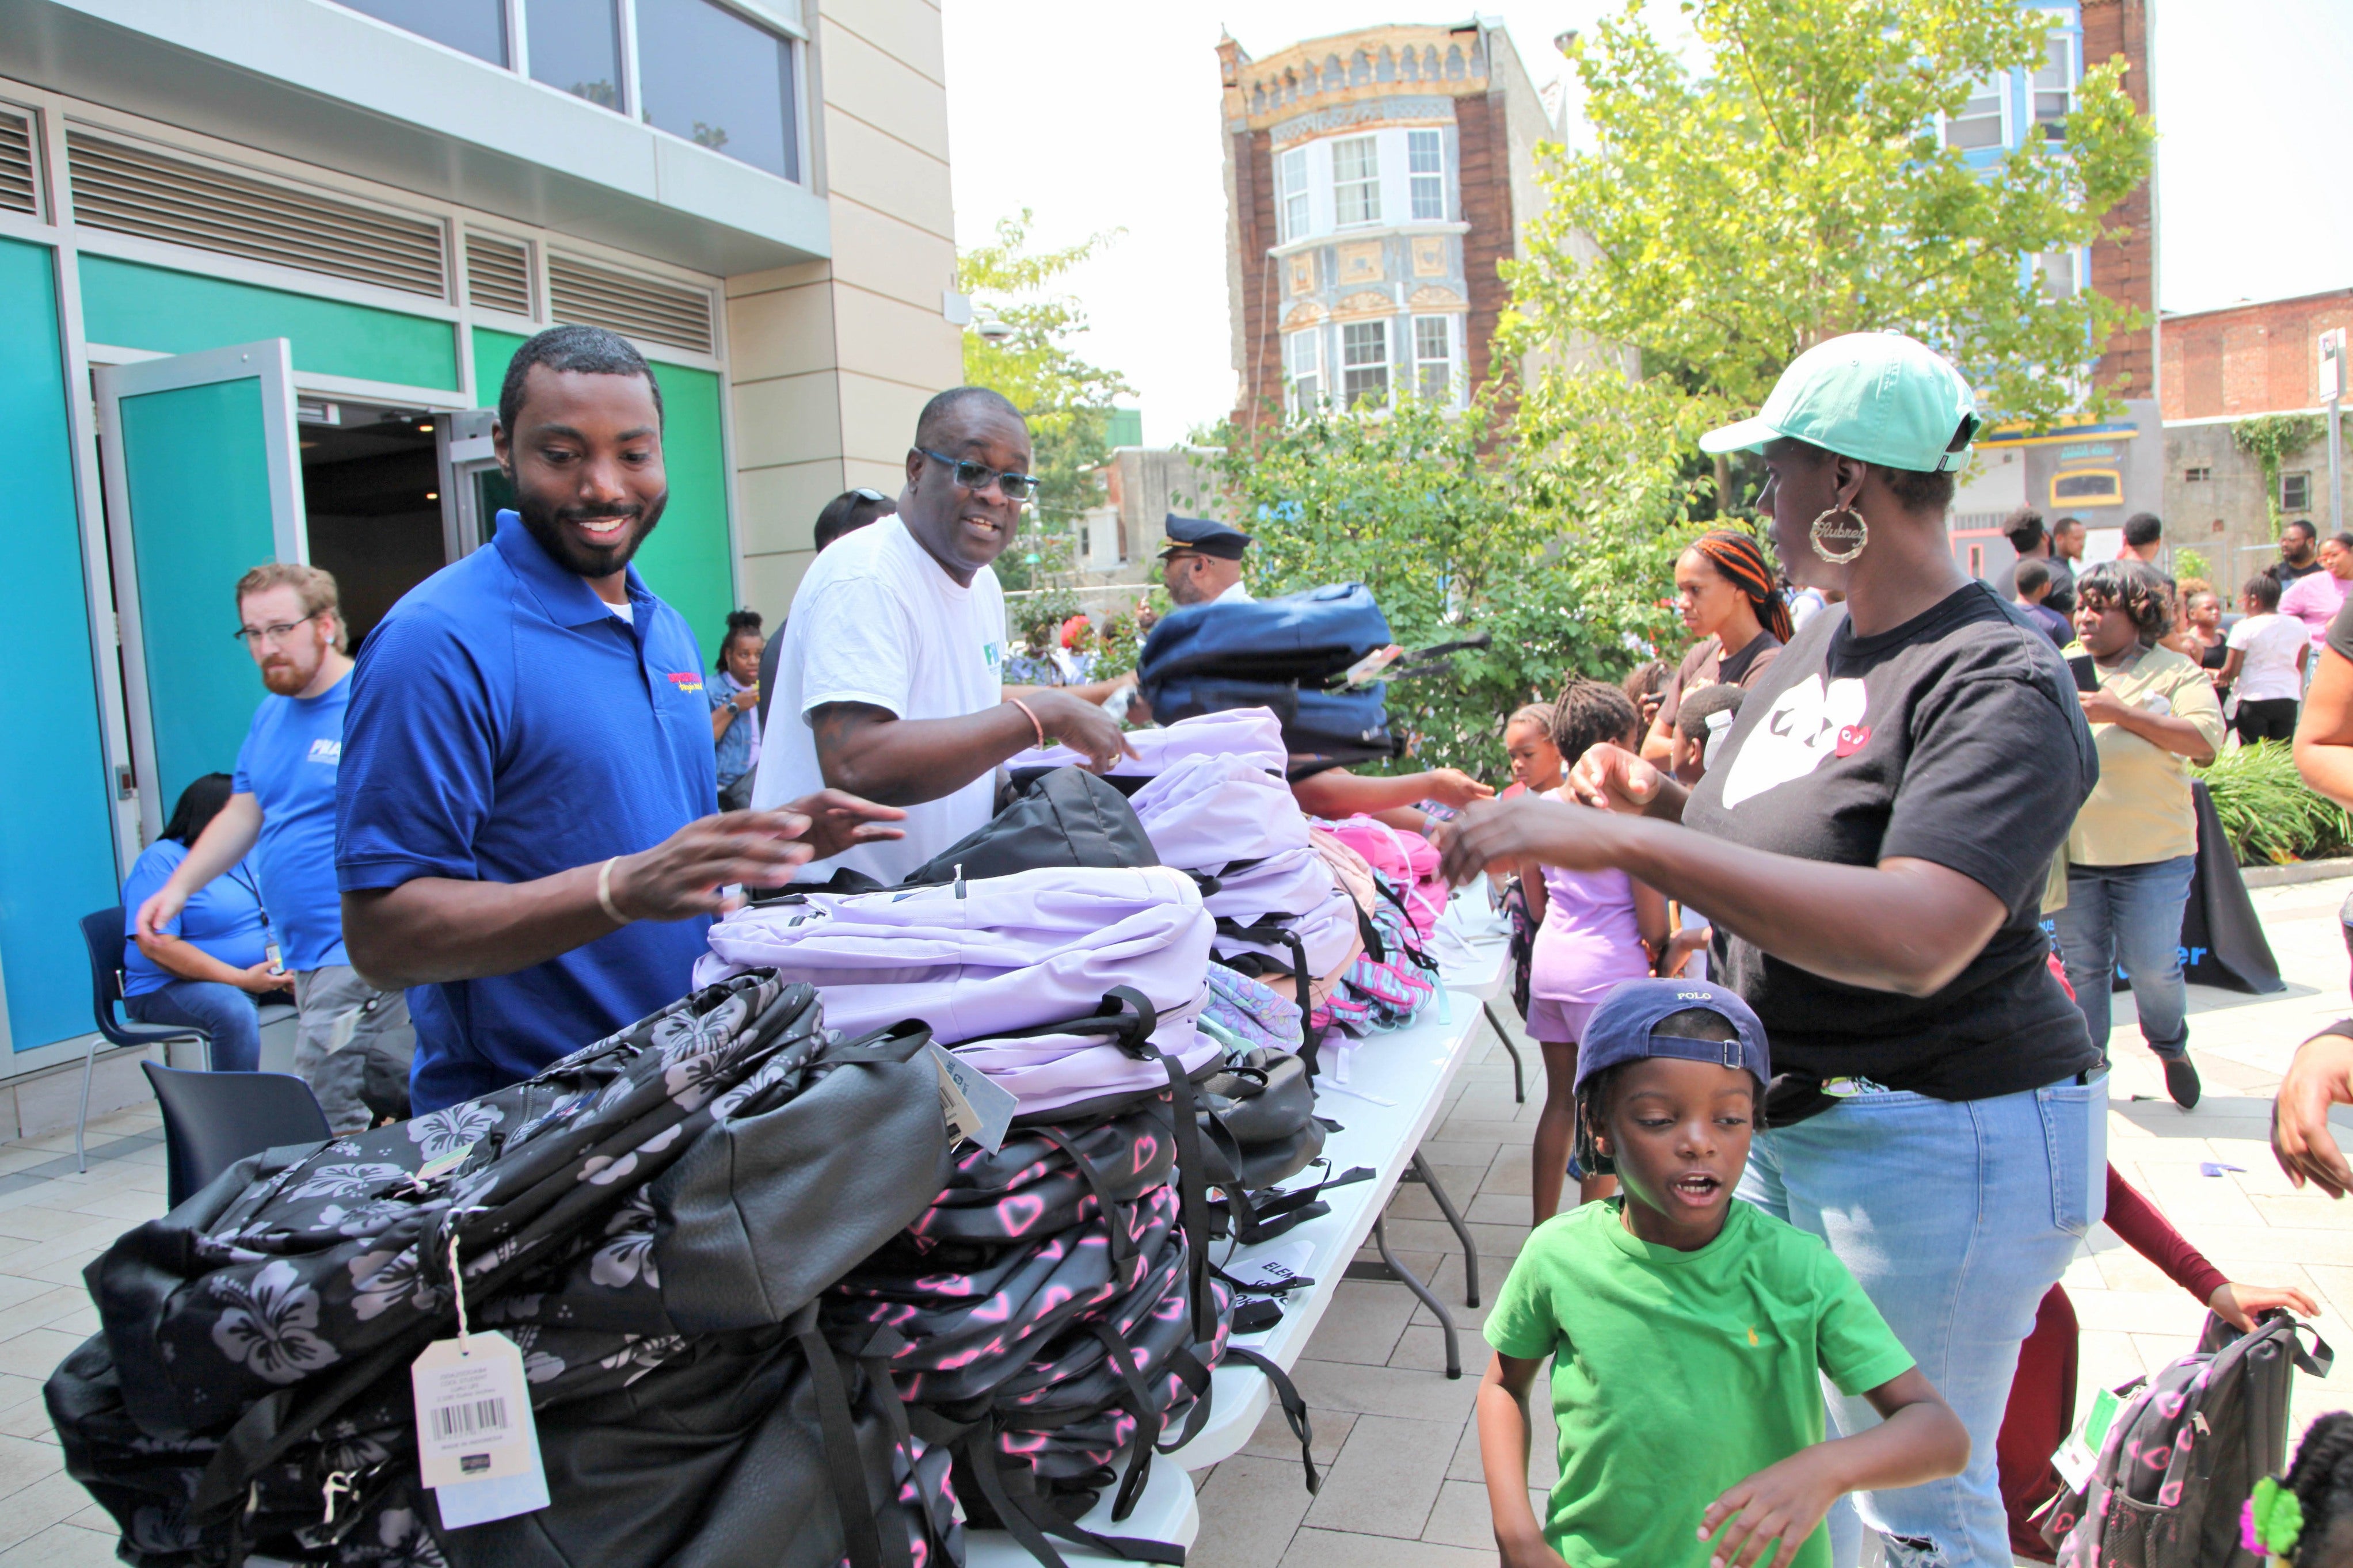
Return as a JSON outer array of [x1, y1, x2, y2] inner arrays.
[[2057, 562, 2221, 1109]]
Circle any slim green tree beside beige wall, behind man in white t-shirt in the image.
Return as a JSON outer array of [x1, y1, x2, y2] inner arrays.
[[955, 207, 1134, 587]]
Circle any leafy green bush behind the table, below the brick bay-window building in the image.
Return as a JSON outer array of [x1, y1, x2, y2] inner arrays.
[[1216, 400, 1680, 778]]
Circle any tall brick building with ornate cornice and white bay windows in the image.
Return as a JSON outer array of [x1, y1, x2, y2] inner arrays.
[[1216, 21, 1560, 421]]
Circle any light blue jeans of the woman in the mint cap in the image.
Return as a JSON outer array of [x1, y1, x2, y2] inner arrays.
[[1739, 1077, 2108, 1568]]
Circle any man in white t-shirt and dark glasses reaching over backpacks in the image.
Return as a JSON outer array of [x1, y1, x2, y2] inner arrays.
[[753, 386, 1127, 884]]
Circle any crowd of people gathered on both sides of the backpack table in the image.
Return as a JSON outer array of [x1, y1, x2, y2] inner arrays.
[[111, 327, 2353, 1568]]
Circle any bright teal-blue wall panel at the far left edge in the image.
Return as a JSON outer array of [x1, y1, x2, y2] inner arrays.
[[0, 240, 123, 1051]]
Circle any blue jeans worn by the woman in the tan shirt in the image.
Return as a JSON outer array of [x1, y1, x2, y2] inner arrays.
[[2052, 856, 2198, 1055]]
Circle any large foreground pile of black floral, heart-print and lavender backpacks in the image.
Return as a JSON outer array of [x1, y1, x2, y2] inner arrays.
[[47, 677, 1431, 1568]]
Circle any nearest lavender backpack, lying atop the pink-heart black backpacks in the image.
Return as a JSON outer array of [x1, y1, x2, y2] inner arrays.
[[694, 865, 1219, 1119]]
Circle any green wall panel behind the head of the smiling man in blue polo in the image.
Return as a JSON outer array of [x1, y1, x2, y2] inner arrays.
[[473, 327, 737, 661]]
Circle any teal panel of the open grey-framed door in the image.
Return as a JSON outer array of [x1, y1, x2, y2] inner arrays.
[[120, 379, 277, 816]]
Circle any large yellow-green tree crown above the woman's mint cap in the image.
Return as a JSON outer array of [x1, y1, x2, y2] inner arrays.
[[1503, 0, 2150, 425]]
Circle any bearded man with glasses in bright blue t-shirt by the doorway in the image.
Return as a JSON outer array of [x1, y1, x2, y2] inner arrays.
[[136, 562, 417, 1133]]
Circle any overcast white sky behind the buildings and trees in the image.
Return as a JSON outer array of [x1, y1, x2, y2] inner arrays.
[[946, 0, 2353, 444]]
